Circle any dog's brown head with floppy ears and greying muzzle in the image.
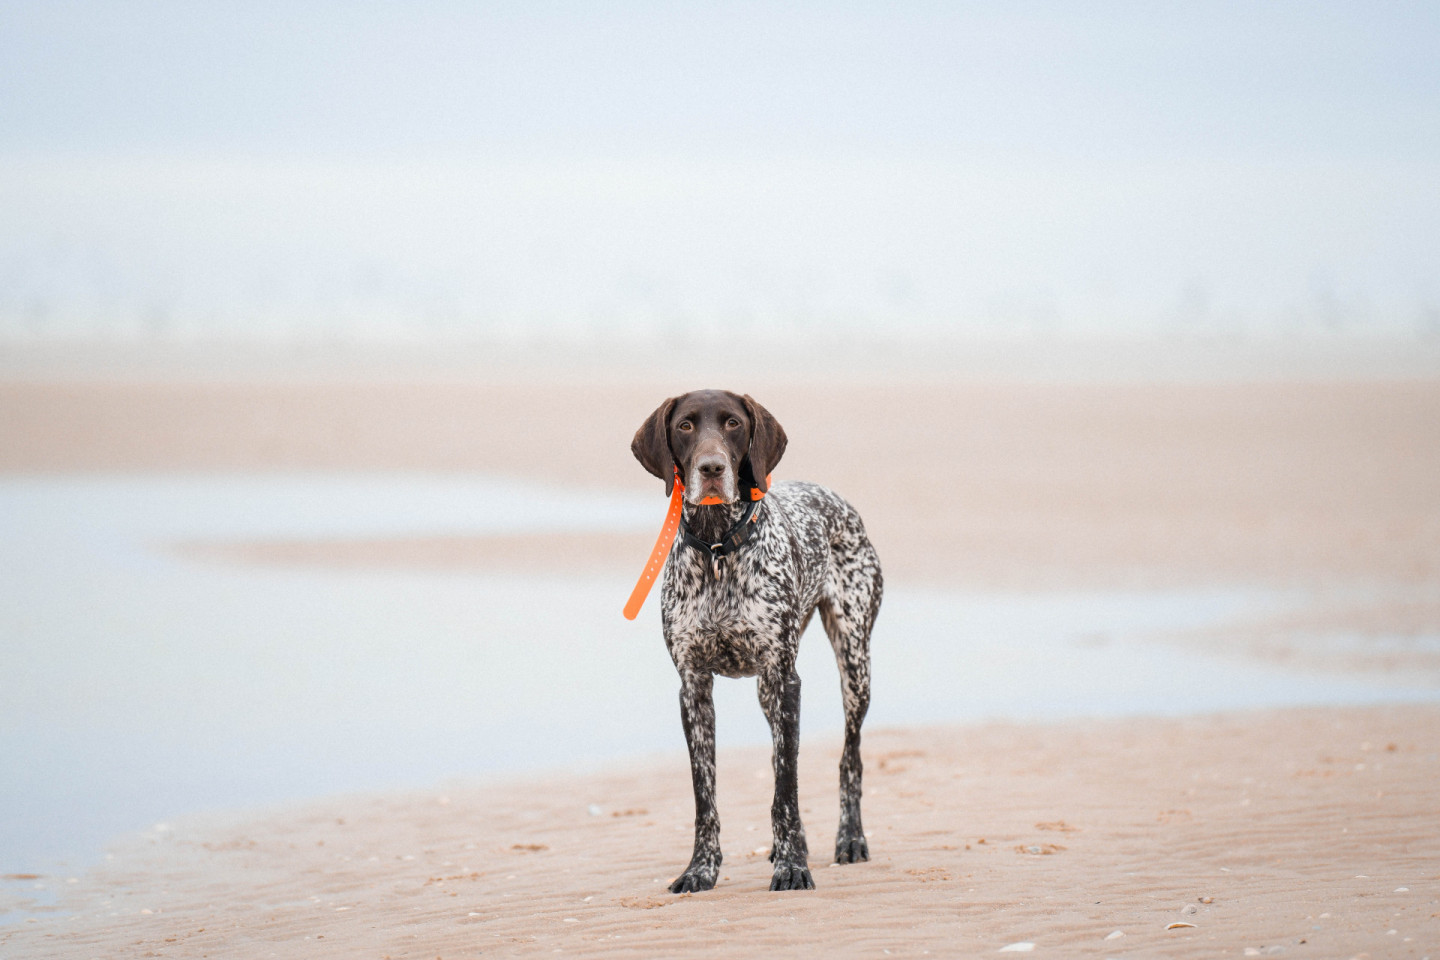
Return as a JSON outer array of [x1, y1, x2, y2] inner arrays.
[[631, 390, 786, 504]]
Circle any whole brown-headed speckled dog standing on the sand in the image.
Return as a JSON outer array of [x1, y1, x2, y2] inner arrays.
[[631, 390, 884, 894]]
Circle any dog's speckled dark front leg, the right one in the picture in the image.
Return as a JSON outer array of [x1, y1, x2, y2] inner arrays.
[[757, 666, 815, 889]]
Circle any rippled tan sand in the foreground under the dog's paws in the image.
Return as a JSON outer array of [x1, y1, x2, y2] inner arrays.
[[0, 705, 1440, 959]]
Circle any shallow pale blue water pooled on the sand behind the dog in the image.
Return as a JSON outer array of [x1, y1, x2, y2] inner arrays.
[[0, 475, 1440, 903]]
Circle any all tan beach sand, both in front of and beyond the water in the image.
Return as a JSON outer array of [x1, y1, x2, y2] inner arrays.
[[0, 355, 1440, 959]]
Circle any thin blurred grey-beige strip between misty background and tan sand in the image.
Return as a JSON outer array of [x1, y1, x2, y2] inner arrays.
[[8, 338, 1440, 389]]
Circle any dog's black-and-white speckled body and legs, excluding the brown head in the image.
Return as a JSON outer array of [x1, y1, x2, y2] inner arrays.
[[661, 480, 883, 892]]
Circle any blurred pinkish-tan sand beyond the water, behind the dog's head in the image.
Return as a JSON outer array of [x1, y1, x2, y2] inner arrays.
[[0, 379, 1440, 587]]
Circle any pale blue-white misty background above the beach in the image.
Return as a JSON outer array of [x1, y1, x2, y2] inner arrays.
[[0, 0, 1440, 345]]
